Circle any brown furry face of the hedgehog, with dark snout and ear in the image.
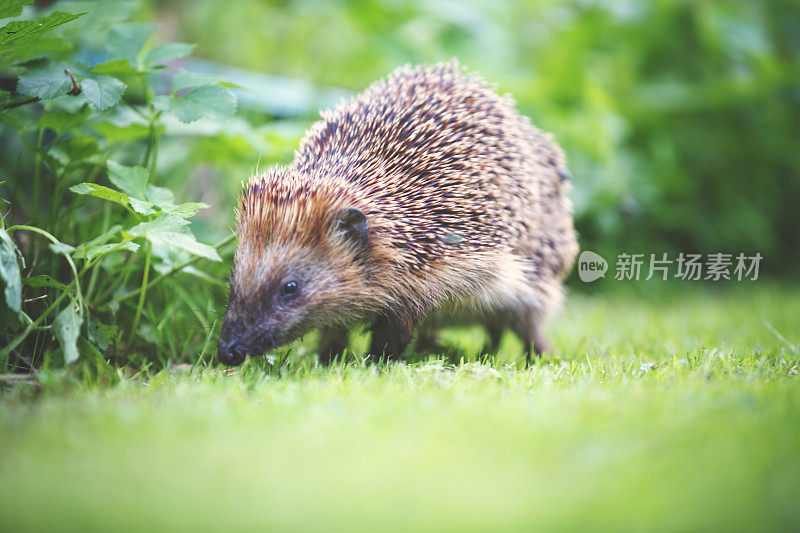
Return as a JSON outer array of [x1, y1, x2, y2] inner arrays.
[[217, 208, 369, 365]]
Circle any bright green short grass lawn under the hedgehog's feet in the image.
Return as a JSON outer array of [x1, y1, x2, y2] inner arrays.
[[0, 285, 800, 531]]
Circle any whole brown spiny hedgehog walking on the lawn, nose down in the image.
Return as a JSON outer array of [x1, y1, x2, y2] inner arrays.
[[217, 61, 578, 365]]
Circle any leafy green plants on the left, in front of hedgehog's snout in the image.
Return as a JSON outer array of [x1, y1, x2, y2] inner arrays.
[[0, 0, 236, 369]]
